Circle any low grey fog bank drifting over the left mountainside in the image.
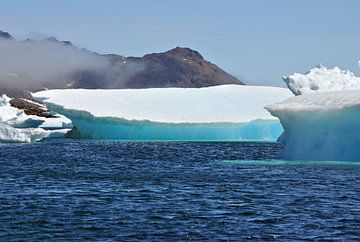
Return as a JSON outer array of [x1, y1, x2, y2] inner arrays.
[[0, 37, 144, 94]]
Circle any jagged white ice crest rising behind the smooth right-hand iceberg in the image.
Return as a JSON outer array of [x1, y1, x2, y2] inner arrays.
[[283, 65, 360, 95]]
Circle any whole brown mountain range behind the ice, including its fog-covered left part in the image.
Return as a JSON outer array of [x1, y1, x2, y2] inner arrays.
[[0, 31, 243, 97]]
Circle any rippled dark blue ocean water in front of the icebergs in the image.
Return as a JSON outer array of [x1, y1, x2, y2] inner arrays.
[[0, 140, 360, 241]]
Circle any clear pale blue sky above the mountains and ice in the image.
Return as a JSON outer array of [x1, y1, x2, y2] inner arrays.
[[0, 0, 360, 86]]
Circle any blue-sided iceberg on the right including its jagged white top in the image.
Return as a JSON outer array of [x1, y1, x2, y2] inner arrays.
[[266, 66, 360, 161]]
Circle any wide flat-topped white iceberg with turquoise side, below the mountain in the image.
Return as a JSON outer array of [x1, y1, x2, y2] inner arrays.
[[33, 85, 293, 141]]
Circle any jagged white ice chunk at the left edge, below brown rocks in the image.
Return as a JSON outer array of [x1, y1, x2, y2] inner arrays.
[[0, 95, 72, 143]]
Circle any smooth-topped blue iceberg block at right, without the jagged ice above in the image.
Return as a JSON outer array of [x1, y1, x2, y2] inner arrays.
[[266, 90, 360, 161]]
